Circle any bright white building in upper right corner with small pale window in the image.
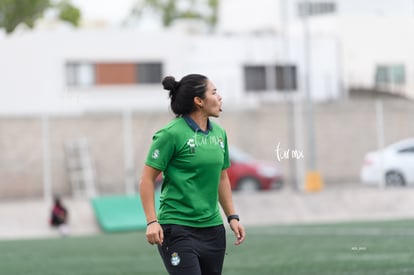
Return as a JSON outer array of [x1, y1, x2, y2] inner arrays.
[[219, 0, 414, 98]]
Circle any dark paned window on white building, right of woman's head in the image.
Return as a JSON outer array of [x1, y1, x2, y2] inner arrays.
[[244, 65, 298, 92]]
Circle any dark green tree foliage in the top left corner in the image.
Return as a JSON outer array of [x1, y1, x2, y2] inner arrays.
[[0, 0, 81, 34]]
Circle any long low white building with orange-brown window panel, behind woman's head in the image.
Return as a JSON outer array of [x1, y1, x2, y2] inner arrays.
[[0, 28, 341, 115]]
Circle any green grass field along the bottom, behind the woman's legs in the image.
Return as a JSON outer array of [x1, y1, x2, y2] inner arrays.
[[0, 220, 414, 275]]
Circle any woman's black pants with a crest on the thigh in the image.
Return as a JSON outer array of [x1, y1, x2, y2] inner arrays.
[[158, 224, 226, 275]]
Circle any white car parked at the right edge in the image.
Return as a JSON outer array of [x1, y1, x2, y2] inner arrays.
[[360, 138, 414, 186]]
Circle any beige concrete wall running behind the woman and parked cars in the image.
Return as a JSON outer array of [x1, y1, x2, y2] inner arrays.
[[0, 99, 414, 198]]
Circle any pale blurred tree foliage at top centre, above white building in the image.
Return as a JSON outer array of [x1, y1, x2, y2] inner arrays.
[[132, 0, 219, 28]]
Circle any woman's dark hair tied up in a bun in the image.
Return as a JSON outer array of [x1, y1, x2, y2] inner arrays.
[[162, 74, 207, 116]]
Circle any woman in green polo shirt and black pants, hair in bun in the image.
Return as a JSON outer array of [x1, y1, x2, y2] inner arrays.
[[140, 74, 245, 275]]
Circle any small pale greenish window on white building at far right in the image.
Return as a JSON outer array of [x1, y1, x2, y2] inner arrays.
[[375, 65, 405, 86]]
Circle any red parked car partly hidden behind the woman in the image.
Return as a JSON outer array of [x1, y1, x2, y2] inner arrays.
[[156, 147, 283, 192]]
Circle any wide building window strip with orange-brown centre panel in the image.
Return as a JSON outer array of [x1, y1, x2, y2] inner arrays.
[[66, 62, 162, 87]]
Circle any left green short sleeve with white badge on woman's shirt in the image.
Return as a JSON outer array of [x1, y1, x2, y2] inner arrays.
[[145, 129, 175, 171]]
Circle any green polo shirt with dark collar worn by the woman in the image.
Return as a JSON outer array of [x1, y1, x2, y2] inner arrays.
[[145, 116, 230, 227]]
